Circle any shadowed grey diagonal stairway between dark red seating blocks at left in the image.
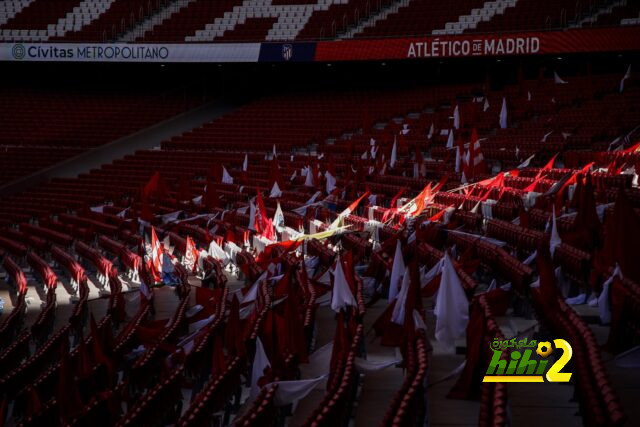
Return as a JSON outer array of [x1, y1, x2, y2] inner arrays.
[[0, 102, 239, 196]]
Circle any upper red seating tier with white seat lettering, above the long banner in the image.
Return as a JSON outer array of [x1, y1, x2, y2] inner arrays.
[[0, 0, 640, 42]]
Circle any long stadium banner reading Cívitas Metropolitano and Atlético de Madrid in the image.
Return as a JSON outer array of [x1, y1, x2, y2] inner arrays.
[[0, 26, 640, 63]]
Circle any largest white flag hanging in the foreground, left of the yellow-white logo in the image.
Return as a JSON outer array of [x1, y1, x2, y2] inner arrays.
[[434, 253, 469, 345]]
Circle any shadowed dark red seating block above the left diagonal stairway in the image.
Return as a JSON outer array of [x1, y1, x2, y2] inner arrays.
[[0, 88, 198, 184]]
